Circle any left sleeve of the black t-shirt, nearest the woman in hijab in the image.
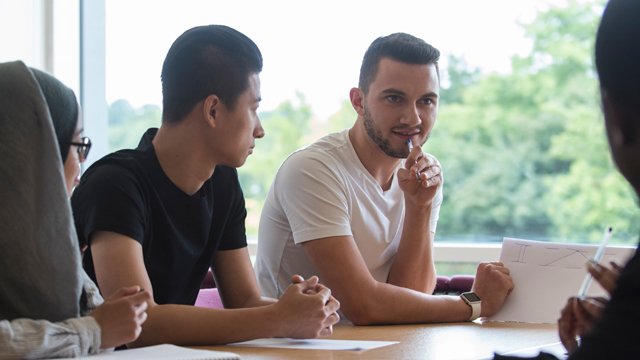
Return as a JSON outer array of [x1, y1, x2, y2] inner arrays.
[[71, 163, 145, 245]]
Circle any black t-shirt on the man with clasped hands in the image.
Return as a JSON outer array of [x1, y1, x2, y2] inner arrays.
[[71, 129, 247, 305]]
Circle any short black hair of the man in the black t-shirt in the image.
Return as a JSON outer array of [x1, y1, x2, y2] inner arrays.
[[162, 25, 262, 123]]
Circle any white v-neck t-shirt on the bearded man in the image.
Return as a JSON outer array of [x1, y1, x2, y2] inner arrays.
[[255, 130, 442, 297]]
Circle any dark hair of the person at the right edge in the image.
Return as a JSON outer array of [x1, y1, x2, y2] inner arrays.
[[595, 0, 640, 107]]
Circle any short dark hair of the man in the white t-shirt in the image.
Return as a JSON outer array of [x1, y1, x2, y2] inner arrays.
[[358, 33, 440, 93]]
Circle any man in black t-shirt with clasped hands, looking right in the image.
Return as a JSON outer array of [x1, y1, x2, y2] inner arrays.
[[72, 25, 339, 346]]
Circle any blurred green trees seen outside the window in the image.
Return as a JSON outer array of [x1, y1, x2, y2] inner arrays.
[[109, 1, 640, 244]]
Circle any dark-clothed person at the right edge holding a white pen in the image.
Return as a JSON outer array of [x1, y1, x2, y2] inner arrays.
[[495, 0, 640, 359]]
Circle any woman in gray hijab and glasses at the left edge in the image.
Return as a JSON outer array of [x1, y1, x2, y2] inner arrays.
[[0, 61, 150, 359]]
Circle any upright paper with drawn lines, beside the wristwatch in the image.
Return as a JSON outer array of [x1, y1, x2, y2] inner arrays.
[[488, 238, 635, 323]]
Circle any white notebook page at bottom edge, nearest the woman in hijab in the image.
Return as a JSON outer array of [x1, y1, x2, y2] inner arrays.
[[52, 344, 240, 360]]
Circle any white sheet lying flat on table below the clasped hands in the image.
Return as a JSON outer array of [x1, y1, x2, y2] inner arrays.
[[229, 338, 398, 351]]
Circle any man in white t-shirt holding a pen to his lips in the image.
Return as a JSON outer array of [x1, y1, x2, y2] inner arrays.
[[256, 33, 513, 325]]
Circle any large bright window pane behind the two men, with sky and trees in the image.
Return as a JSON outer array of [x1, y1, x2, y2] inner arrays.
[[97, 0, 640, 248]]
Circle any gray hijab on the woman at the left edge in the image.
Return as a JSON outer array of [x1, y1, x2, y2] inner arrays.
[[0, 61, 82, 321]]
